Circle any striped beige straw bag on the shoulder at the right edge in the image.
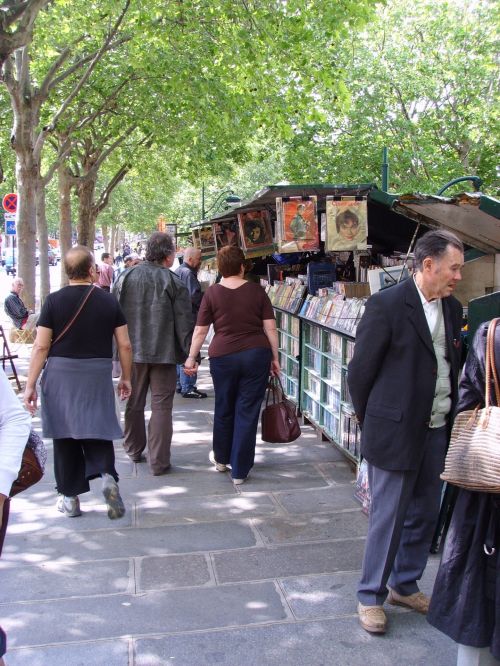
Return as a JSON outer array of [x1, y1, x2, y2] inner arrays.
[[441, 319, 500, 493]]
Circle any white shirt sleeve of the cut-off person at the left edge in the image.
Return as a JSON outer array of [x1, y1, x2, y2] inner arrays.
[[0, 368, 31, 496]]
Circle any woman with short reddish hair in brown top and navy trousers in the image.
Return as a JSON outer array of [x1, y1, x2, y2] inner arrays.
[[184, 246, 280, 484]]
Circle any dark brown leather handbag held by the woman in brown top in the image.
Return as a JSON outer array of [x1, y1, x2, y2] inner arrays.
[[261, 377, 301, 444]]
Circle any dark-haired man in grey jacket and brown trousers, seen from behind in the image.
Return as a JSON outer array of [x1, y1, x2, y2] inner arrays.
[[114, 232, 193, 476]]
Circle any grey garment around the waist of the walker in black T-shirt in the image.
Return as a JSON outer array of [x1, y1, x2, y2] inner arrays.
[[40, 356, 123, 440]]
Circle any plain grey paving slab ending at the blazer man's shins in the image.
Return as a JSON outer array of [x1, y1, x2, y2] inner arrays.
[[213, 539, 364, 583]]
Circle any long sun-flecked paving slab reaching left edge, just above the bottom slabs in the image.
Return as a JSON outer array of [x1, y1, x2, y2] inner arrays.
[[0, 583, 287, 644]]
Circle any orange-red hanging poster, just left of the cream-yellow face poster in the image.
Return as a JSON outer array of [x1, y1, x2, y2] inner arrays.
[[276, 196, 319, 252]]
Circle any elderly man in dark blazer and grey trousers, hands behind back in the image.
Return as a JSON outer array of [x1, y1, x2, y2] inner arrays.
[[348, 230, 464, 634]]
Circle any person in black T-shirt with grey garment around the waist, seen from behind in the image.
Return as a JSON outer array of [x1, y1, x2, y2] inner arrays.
[[24, 245, 132, 519]]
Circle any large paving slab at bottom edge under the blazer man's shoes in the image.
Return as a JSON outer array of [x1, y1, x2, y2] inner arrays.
[[135, 613, 456, 666]]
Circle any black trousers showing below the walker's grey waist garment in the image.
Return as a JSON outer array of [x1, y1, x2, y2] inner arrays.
[[54, 438, 118, 497]]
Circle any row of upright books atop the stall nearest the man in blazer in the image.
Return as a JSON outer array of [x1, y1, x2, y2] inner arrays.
[[299, 294, 366, 335]]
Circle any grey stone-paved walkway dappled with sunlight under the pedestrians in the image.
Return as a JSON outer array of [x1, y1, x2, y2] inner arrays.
[[0, 350, 456, 666]]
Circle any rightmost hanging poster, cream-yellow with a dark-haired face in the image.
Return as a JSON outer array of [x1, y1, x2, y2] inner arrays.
[[325, 197, 368, 252]]
